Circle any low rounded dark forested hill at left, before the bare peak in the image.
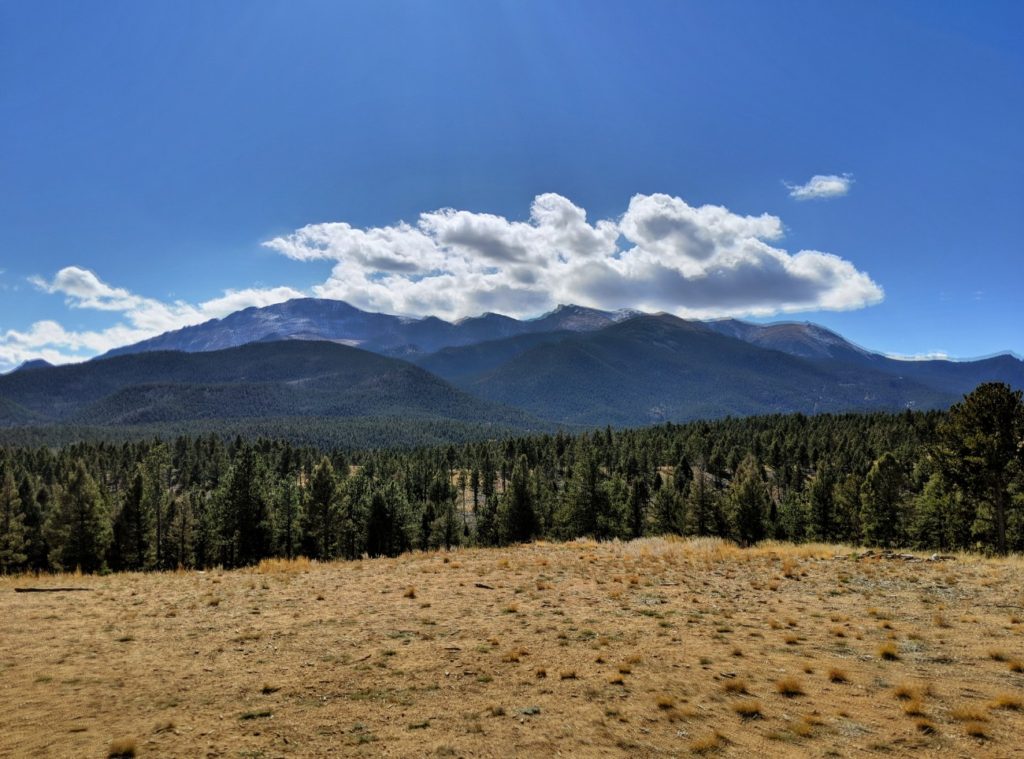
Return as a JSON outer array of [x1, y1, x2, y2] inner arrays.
[[0, 341, 541, 435]]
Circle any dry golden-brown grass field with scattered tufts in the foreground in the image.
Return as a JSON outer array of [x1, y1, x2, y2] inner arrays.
[[0, 539, 1024, 758]]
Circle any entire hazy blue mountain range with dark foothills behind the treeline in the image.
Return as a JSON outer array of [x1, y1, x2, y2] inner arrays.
[[0, 299, 1024, 445]]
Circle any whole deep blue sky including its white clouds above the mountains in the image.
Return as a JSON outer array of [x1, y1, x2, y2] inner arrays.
[[0, 0, 1024, 370]]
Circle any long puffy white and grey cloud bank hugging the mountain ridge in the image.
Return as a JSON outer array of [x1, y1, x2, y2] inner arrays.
[[0, 188, 884, 370]]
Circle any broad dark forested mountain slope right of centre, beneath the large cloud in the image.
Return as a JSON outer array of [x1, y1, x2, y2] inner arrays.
[[444, 314, 954, 426]]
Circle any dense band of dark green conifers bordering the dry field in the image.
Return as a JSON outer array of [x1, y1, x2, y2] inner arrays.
[[0, 383, 1024, 573]]
